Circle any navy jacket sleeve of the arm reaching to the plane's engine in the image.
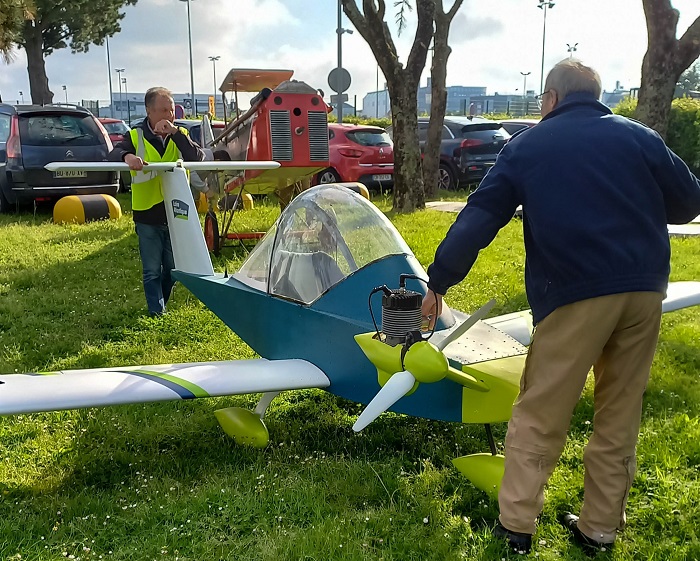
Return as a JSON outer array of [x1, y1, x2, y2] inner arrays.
[[428, 149, 520, 294]]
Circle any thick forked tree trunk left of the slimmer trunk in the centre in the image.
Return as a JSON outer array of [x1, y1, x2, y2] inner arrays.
[[342, 0, 435, 212]]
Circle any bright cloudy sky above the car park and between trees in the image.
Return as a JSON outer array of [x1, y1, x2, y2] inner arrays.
[[0, 0, 700, 106]]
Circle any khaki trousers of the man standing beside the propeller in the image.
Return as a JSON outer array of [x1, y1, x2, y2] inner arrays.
[[498, 292, 663, 542]]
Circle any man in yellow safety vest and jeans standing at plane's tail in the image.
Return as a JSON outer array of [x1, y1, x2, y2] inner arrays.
[[109, 87, 204, 316]]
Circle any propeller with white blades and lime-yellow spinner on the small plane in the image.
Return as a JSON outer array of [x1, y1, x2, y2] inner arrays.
[[352, 300, 496, 432]]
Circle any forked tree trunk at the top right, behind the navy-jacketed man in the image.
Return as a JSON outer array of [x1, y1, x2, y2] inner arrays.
[[635, 0, 700, 137]]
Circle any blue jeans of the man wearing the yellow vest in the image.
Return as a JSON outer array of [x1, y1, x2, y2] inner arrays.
[[136, 222, 175, 315]]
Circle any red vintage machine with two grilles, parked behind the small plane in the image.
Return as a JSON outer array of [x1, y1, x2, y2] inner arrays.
[[204, 68, 330, 254]]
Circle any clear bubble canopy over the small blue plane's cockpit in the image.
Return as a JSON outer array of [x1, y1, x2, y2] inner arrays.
[[233, 185, 413, 304]]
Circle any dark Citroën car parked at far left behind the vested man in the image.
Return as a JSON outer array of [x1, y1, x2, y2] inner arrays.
[[0, 103, 119, 212]]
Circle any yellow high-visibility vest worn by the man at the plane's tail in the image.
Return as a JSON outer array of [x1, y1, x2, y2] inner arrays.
[[129, 127, 187, 210]]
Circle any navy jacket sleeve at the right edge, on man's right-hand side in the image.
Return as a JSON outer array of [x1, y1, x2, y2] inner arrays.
[[653, 133, 700, 224]]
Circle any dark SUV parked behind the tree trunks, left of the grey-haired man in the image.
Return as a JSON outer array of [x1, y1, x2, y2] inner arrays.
[[418, 117, 510, 189]]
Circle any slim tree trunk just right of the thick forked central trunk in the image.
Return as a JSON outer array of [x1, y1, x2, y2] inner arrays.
[[423, 0, 462, 199]]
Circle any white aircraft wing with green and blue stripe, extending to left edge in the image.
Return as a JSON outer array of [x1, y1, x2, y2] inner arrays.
[[0, 358, 330, 415]]
